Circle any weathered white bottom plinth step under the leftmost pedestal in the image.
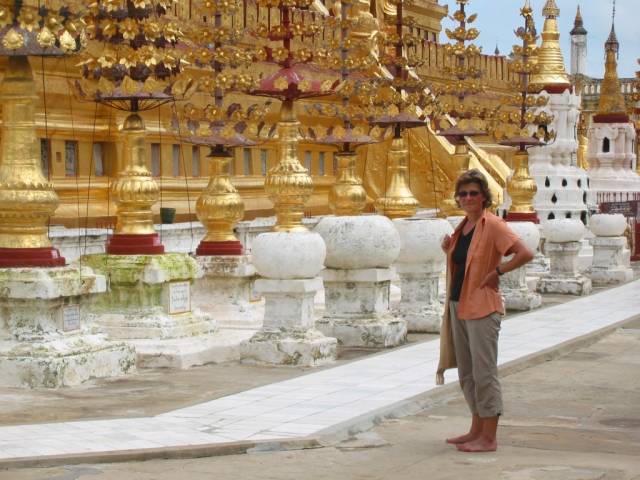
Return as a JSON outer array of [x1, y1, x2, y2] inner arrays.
[[0, 335, 135, 388]]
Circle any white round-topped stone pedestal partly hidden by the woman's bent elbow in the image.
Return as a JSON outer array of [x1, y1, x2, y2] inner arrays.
[[500, 222, 542, 312]]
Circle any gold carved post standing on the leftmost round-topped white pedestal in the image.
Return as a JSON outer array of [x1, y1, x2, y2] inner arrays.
[[264, 100, 313, 232]]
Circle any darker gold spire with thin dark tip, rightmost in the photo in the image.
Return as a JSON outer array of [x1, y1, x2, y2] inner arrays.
[[593, 24, 629, 123]]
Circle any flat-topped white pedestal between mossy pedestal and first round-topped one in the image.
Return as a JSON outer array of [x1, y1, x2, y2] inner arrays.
[[193, 255, 262, 330]]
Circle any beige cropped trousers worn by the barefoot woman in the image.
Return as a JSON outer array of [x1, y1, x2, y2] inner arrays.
[[449, 301, 502, 418]]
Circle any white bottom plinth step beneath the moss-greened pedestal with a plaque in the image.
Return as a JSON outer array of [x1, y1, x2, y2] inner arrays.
[[127, 330, 255, 369]]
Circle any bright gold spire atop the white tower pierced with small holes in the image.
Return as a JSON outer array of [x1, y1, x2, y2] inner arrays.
[[531, 0, 571, 93]]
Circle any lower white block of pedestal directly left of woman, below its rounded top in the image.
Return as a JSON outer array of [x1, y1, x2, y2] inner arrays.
[[393, 262, 445, 333]]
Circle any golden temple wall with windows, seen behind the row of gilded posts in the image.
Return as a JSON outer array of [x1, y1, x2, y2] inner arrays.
[[0, 1, 510, 226]]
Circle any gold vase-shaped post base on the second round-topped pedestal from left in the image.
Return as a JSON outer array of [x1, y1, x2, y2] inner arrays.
[[329, 152, 367, 215]]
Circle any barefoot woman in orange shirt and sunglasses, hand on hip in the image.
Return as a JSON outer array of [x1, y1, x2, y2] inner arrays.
[[436, 169, 533, 452]]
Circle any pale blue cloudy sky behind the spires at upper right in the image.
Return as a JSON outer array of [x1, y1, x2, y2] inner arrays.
[[439, 0, 640, 78]]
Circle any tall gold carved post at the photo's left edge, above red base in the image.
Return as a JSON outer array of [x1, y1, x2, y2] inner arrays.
[[0, 56, 59, 248]]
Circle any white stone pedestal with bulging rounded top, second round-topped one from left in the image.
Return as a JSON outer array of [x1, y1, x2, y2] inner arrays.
[[315, 215, 407, 348]]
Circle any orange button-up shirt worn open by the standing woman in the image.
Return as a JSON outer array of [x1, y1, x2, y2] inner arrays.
[[447, 210, 519, 320]]
